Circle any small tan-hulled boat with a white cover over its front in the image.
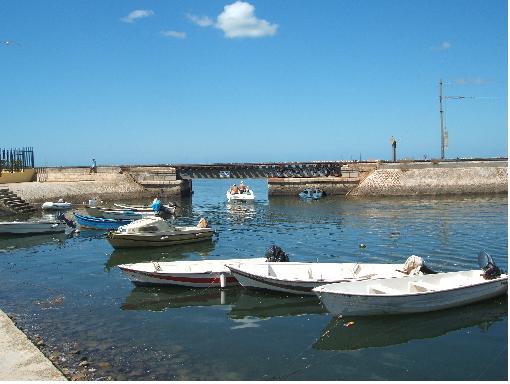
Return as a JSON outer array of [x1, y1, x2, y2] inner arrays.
[[107, 217, 214, 248]]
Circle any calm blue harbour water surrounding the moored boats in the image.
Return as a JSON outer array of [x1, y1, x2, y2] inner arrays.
[[0, 180, 508, 380]]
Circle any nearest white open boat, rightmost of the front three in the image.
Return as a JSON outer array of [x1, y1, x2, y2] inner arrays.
[[313, 252, 508, 316]]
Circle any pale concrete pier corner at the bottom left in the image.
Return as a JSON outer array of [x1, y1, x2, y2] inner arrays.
[[0, 310, 67, 381]]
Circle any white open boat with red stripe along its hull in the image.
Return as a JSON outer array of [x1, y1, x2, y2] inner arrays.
[[119, 258, 265, 288]]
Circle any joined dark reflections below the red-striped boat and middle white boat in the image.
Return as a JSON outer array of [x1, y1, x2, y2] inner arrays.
[[121, 287, 326, 319]]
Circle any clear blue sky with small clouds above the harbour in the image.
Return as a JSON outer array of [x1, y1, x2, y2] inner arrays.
[[0, 0, 508, 166]]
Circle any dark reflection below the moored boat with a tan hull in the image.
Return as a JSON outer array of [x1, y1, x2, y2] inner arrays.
[[105, 241, 216, 270]]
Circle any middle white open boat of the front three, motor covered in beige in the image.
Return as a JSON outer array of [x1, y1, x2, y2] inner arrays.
[[229, 255, 430, 295]]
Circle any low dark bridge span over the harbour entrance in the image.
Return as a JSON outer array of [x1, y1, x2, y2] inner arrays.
[[171, 161, 342, 179]]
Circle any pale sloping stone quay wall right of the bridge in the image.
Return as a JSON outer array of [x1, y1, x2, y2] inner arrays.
[[348, 161, 508, 196]]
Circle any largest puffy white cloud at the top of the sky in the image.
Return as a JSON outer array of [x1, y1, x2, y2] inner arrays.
[[215, 1, 278, 38]]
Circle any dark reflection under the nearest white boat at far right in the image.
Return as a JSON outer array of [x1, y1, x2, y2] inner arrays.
[[313, 296, 508, 351]]
